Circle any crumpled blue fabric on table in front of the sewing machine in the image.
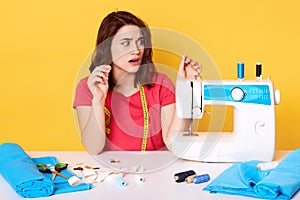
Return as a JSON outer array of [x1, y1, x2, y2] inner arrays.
[[203, 149, 300, 199]]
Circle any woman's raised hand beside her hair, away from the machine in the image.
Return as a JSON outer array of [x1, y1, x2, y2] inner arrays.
[[88, 65, 111, 101]]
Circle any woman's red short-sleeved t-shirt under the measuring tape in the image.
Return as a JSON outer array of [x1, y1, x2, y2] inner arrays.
[[73, 73, 175, 151]]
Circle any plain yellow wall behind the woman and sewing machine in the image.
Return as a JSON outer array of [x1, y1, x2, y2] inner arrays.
[[0, 0, 300, 150]]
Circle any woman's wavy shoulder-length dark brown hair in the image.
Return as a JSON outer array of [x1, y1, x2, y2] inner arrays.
[[89, 11, 156, 88]]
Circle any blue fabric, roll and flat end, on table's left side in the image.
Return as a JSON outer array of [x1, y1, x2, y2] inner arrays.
[[0, 143, 92, 198]]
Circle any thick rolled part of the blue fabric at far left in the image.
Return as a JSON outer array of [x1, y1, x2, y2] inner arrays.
[[0, 143, 55, 198]]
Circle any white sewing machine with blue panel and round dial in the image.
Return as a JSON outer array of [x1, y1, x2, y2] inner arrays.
[[172, 64, 280, 162]]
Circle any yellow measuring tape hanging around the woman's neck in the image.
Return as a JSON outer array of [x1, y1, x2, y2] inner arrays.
[[104, 86, 149, 151]]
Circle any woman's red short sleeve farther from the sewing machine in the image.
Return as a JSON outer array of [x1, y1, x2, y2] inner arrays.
[[73, 77, 93, 108]]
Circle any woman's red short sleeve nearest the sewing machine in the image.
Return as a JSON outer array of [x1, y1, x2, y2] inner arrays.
[[160, 75, 176, 106]]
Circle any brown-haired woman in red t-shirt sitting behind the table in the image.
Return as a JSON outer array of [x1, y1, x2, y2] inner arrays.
[[73, 11, 201, 154]]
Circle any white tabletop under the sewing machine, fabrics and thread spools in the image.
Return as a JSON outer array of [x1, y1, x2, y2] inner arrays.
[[0, 151, 300, 200]]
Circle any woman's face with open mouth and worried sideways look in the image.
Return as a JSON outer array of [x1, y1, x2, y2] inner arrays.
[[111, 25, 144, 73]]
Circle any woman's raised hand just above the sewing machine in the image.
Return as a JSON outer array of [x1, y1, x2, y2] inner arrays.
[[178, 55, 202, 80]]
